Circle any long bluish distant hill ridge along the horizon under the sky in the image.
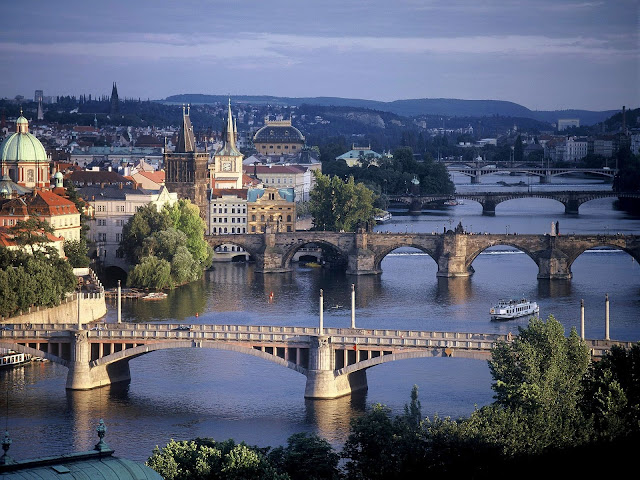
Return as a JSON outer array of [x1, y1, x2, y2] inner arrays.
[[159, 94, 618, 125]]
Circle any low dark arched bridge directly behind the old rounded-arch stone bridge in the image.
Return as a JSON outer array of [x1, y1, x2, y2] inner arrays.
[[389, 190, 640, 216]]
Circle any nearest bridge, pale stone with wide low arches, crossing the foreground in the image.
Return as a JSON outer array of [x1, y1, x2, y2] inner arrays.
[[0, 323, 631, 399]]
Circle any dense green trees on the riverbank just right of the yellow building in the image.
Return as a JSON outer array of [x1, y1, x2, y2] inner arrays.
[[309, 170, 375, 232]]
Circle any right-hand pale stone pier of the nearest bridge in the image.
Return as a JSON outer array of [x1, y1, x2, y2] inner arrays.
[[304, 335, 368, 400]]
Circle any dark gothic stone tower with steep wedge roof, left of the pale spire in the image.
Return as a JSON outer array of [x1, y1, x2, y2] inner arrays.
[[164, 106, 209, 219]]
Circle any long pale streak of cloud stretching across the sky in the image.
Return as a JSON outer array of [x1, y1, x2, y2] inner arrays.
[[0, 33, 638, 64]]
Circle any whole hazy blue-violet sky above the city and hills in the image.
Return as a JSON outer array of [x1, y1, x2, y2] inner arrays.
[[0, 0, 640, 110]]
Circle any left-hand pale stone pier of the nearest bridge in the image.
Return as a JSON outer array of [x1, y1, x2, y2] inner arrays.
[[66, 330, 131, 390]]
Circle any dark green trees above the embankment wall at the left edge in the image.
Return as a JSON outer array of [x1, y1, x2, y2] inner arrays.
[[0, 246, 76, 316]]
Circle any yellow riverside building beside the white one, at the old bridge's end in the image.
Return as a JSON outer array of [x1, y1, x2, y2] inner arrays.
[[247, 188, 296, 233]]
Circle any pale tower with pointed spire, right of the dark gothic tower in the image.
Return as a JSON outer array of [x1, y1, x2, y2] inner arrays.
[[209, 99, 242, 189]]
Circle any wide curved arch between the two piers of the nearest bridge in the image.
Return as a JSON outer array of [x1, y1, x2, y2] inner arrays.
[[89, 340, 307, 375]]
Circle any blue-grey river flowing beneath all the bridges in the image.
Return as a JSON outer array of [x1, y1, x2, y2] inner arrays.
[[0, 177, 640, 461]]
